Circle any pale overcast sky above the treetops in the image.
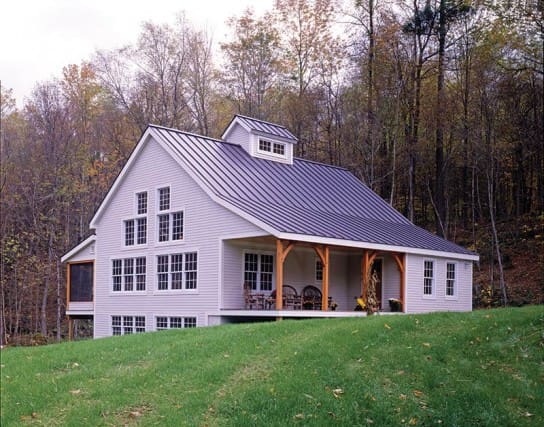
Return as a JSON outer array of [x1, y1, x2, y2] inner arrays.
[[0, 0, 273, 107]]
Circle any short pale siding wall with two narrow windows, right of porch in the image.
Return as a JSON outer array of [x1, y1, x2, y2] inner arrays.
[[405, 255, 472, 313]]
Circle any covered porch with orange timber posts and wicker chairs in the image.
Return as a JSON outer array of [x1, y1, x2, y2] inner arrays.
[[221, 236, 406, 318]]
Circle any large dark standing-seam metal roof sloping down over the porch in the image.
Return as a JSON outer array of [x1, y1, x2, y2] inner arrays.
[[146, 125, 478, 260]]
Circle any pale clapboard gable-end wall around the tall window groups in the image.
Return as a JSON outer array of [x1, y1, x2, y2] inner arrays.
[[94, 140, 260, 337]]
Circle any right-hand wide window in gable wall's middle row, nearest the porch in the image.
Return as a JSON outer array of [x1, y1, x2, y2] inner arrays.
[[157, 252, 198, 291]]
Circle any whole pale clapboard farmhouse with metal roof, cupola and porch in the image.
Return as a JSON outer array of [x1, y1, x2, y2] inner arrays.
[[63, 116, 478, 337]]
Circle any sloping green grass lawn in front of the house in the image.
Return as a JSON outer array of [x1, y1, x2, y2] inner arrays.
[[1, 306, 544, 427]]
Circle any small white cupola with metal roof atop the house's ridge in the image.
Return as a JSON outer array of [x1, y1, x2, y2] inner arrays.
[[222, 115, 297, 164]]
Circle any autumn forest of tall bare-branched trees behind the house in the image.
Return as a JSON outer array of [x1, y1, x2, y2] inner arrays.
[[0, 0, 544, 344]]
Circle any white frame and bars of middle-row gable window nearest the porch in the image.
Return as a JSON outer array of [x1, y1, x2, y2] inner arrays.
[[154, 251, 200, 295]]
